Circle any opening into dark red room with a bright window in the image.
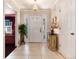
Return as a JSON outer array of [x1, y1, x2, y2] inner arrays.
[[5, 15, 15, 57]]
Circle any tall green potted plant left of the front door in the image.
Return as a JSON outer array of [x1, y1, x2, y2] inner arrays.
[[19, 24, 27, 45]]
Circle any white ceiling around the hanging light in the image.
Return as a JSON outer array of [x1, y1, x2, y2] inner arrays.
[[4, 0, 59, 9]]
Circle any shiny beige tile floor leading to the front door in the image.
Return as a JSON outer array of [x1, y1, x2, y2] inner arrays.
[[6, 43, 64, 59]]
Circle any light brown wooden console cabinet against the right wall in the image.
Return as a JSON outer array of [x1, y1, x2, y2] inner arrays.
[[48, 34, 58, 51]]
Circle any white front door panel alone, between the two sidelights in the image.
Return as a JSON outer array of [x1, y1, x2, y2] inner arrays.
[[29, 15, 43, 42]]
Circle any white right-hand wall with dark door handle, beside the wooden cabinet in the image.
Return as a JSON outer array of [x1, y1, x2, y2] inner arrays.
[[52, 0, 76, 59]]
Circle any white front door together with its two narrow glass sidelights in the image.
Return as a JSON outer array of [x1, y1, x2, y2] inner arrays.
[[25, 14, 48, 43]]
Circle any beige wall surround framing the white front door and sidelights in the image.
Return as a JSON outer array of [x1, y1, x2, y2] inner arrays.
[[21, 9, 50, 42]]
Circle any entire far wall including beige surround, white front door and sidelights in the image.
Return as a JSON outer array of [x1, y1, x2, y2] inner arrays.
[[21, 10, 49, 42]]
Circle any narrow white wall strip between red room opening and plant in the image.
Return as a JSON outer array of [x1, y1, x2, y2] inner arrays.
[[15, 9, 20, 46]]
